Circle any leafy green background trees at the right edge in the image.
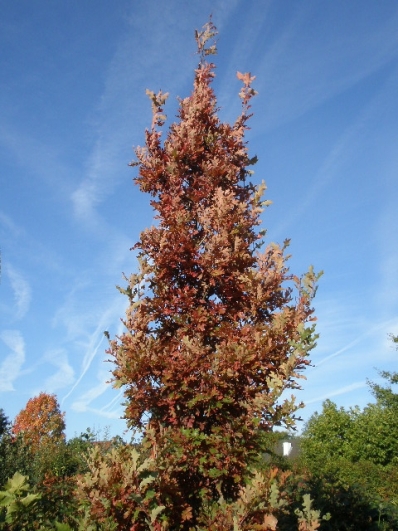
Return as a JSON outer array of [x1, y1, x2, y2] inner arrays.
[[301, 337, 398, 530]]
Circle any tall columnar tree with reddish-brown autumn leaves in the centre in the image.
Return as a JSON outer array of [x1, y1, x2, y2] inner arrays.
[[109, 23, 317, 523]]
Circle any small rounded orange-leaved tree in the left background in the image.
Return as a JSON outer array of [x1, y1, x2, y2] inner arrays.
[[12, 393, 65, 452]]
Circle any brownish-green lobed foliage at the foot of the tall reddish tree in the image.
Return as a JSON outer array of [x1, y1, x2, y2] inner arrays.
[[77, 446, 328, 531]]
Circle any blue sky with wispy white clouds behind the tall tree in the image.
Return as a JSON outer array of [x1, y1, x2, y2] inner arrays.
[[0, 0, 398, 436]]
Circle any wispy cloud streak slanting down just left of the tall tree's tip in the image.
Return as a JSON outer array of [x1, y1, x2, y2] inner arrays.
[[70, 0, 232, 233]]
